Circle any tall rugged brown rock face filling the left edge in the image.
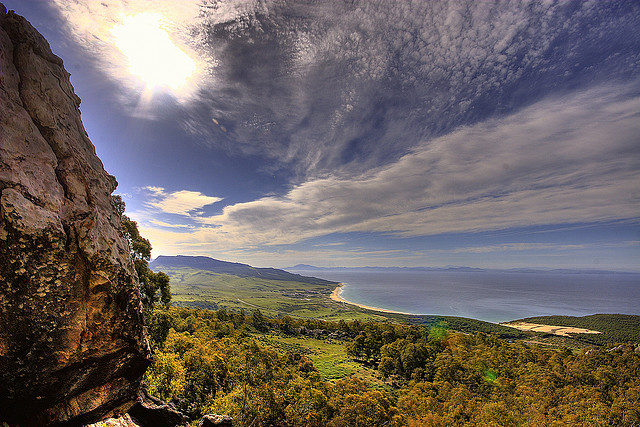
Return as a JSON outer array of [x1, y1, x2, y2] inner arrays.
[[0, 4, 149, 426]]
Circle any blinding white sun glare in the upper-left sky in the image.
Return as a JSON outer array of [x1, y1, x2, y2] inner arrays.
[[111, 13, 196, 91]]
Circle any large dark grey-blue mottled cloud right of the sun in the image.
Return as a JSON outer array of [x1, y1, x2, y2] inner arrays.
[[186, 1, 640, 176]]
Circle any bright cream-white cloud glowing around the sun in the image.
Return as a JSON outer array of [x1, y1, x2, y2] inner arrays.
[[53, 0, 204, 98]]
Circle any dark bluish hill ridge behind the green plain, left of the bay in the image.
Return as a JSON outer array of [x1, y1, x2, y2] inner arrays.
[[149, 255, 337, 285]]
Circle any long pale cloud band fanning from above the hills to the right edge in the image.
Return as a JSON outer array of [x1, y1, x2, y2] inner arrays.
[[139, 85, 640, 254]]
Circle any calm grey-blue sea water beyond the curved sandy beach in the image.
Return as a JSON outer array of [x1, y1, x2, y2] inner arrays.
[[296, 270, 640, 322]]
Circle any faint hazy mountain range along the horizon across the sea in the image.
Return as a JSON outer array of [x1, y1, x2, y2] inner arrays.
[[284, 264, 638, 274]]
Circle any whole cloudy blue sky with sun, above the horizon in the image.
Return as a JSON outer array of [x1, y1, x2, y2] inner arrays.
[[3, 0, 640, 271]]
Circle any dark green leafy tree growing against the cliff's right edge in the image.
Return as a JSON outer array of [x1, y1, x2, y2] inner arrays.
[[113, 195, 171, 324]]
